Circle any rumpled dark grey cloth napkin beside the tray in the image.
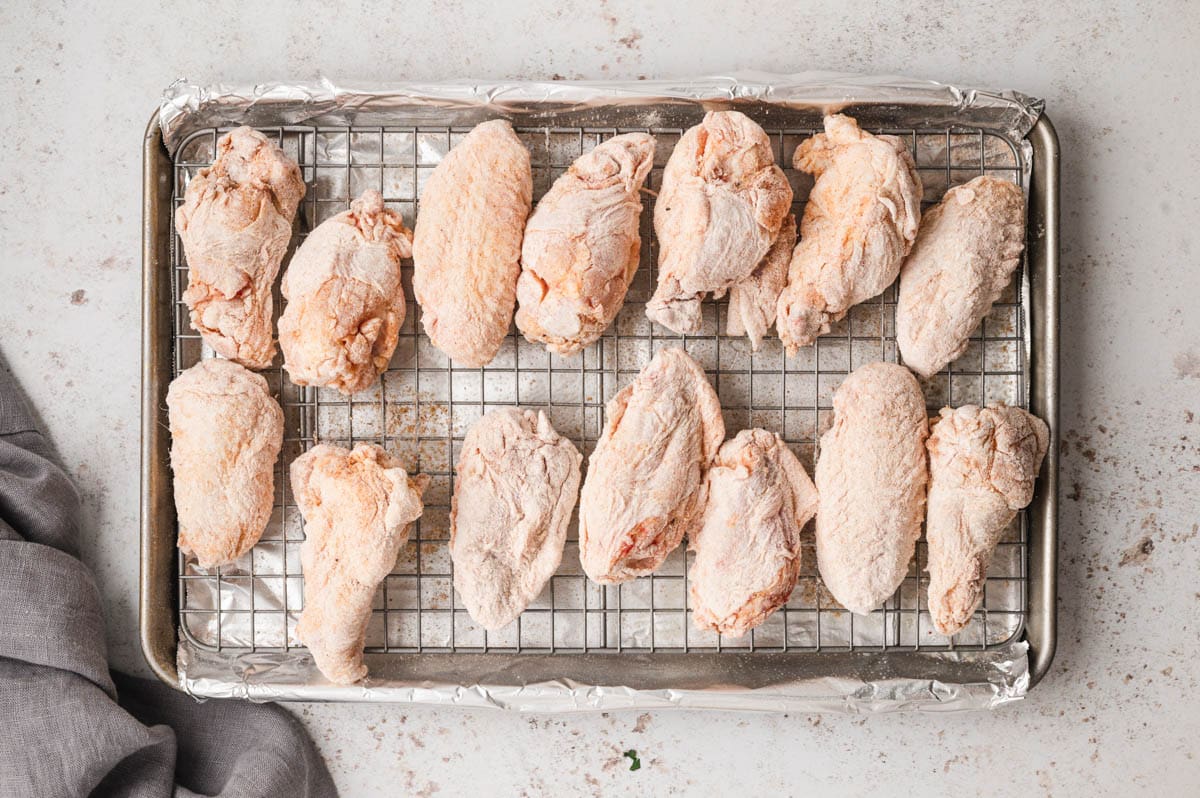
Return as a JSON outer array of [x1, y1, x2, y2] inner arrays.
[[0, 362, 336, 798]]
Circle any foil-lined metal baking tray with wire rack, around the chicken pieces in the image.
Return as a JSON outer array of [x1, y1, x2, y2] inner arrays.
[[140, 76, 1058, 710]]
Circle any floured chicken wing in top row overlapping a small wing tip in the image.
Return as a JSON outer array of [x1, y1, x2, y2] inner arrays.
[[646, 110, 792, 334]]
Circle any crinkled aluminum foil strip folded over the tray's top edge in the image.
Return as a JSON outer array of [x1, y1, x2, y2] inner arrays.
[[158, 72, 1044, 154]]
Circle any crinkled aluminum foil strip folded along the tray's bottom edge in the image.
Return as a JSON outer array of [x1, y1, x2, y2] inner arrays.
[[179, 641, 1030, 714]]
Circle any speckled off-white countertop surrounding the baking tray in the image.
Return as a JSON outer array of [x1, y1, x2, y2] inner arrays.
[[0, 0, 1200, 796]]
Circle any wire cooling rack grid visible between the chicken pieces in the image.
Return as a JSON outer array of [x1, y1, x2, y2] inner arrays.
[[172, 126, 1028, 653]]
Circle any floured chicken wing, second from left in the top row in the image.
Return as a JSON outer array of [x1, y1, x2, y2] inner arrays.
[[280, 191, 413, 395]]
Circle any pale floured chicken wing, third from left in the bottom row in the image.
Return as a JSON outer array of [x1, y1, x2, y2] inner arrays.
[[450, 408, 583, 630]]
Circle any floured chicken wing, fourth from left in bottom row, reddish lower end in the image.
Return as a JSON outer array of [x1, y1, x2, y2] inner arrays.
[[580, 349, 725, 583]]
